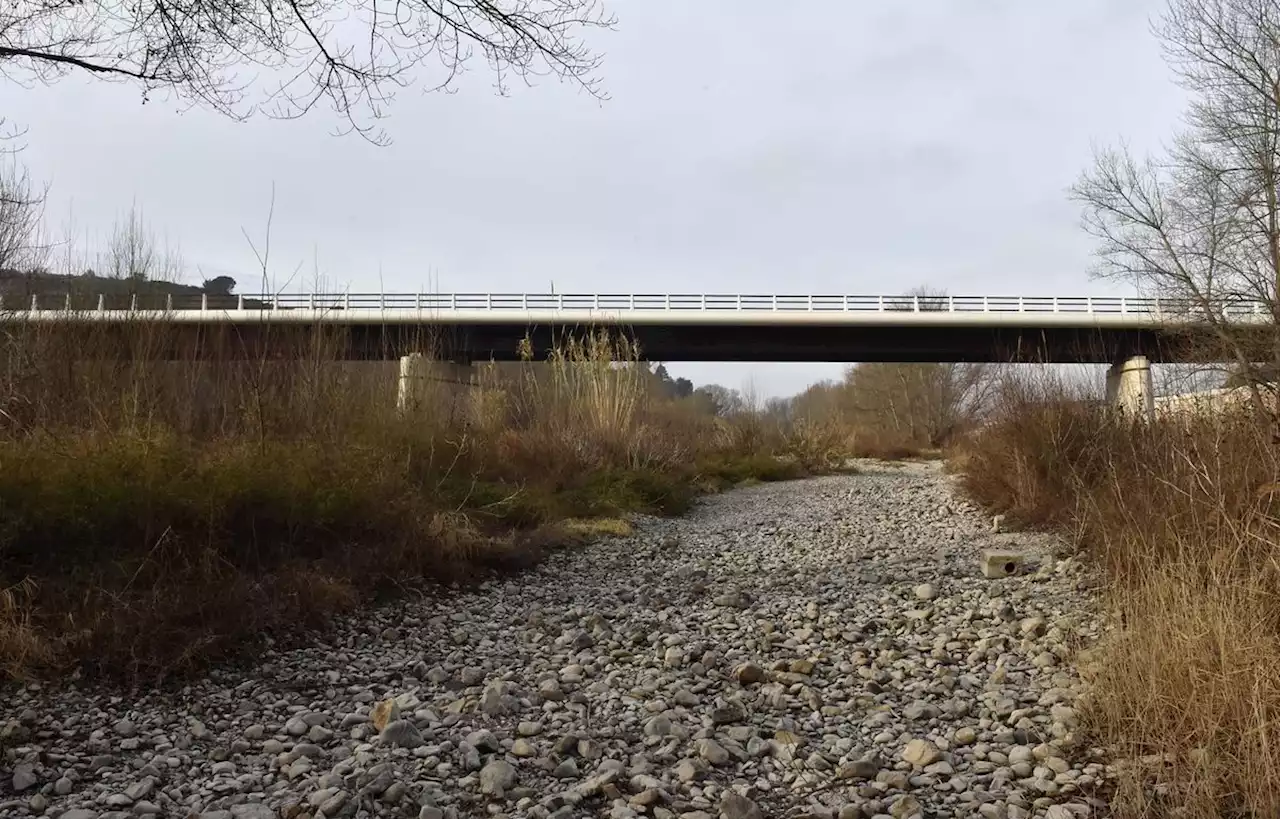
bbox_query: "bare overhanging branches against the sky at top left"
[0,0,613,142]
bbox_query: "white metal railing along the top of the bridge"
[0,293,1270,317]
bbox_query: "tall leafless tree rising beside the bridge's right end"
[1073,0,1280,402]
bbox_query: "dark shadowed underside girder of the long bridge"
[7,321,1212,363]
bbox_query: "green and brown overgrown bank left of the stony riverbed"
[0,326,840,681]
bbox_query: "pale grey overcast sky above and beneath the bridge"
[0,0,1183,394]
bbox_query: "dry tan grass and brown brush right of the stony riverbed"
[956,388,1280,819]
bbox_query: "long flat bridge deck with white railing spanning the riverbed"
[0,293,1271,363]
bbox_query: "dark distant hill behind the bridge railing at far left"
[0,269,265,310]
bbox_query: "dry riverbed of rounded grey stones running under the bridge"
[0,465,1105,819]
